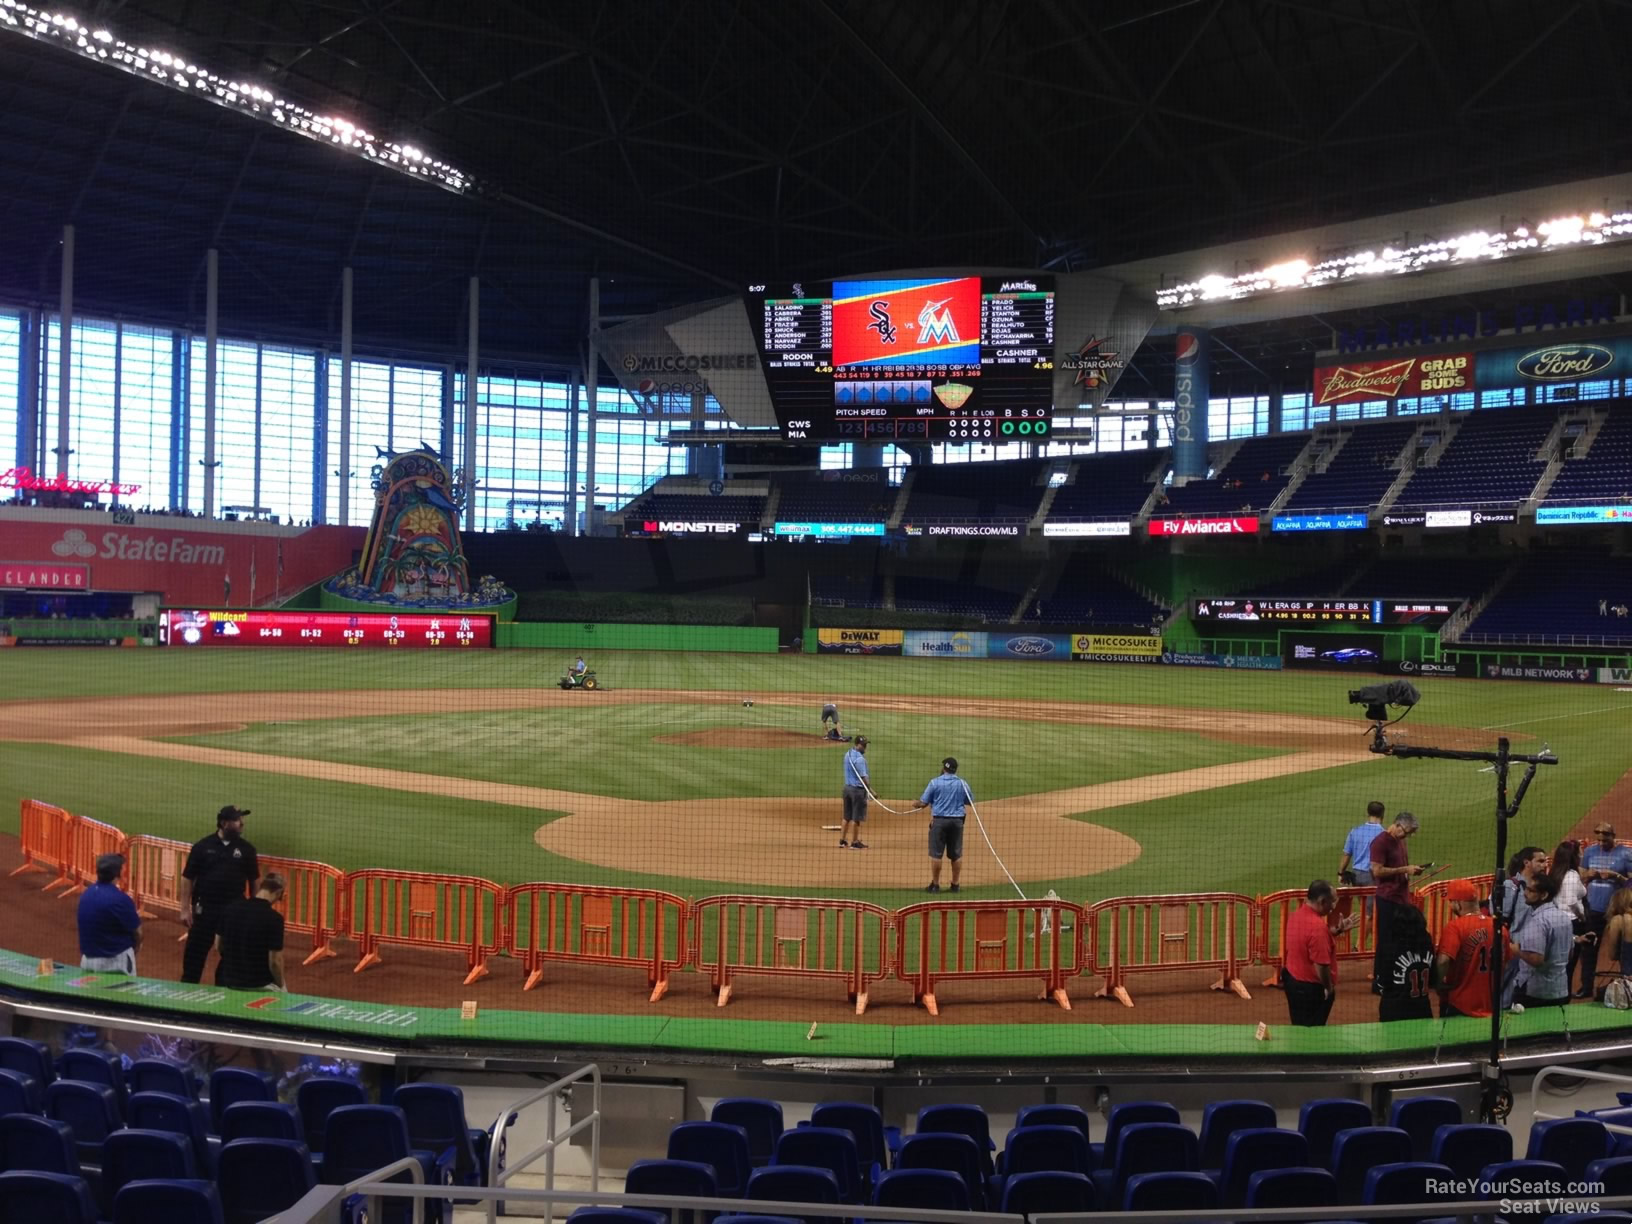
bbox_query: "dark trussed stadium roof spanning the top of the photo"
[0,0,1632,393]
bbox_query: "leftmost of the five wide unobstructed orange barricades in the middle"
[343,868,504,986]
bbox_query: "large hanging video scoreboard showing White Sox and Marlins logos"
[747,276,1054,442]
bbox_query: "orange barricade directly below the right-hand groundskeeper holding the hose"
[894,898,1087,1015]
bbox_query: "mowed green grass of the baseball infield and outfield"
[0,650,1632,904]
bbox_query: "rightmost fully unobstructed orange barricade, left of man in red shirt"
[1087,893,1260,1007]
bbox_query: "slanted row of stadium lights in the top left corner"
[0,0,485,196]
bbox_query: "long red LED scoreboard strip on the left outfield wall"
[158,607,493,650]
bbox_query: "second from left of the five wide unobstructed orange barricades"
[504,883,690,1002]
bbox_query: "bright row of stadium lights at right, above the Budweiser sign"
[1155,212,1632,310]
